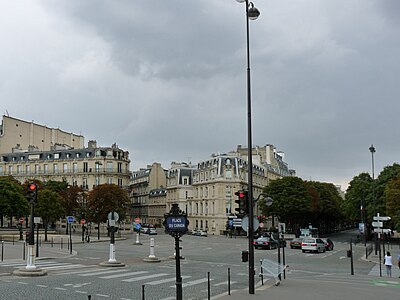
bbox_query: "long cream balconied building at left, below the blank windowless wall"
[0,141,131,190]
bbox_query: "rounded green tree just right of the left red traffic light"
[35,188,65,241]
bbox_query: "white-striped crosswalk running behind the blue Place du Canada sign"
[0,261,236,288]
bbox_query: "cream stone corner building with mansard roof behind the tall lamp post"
[187,145,295,235]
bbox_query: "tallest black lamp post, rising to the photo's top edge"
[236,0,260,294]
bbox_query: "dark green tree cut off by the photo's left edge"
[0,176,29,226]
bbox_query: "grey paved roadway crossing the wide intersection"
[0,234,398,300]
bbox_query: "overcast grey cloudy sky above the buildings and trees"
[0,0,400,190]
